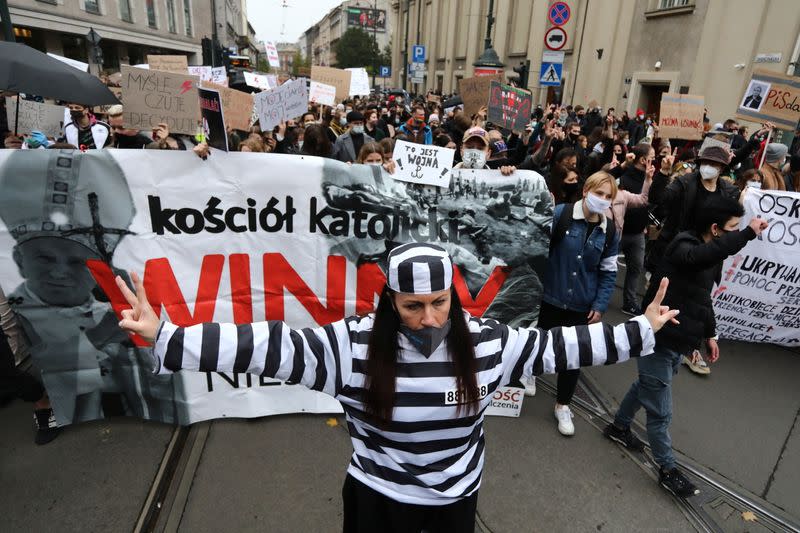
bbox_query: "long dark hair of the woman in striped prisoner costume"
[364,287,480,427]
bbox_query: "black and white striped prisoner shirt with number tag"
[154,313,655,505]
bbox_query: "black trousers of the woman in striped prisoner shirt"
[342,474,478,533]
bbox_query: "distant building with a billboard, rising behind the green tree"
[298,0,393,66]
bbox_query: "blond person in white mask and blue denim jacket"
[526,171,619,436]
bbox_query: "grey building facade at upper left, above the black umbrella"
[8,0,212,71]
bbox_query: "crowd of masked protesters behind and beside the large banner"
[0,76,800,502]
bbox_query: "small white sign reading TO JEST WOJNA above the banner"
[392,141,456,187]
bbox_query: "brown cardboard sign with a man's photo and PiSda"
[736,69,800,130]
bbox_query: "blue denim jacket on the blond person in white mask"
[544,202,619,313]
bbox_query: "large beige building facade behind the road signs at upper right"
[390,0,800,127]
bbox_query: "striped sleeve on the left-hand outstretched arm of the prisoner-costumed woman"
[153,320,351,396]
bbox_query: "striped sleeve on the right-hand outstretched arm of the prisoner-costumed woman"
[503,315,655,382]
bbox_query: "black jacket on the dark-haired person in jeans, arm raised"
[643,227,756,354]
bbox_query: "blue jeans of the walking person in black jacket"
[614,345,681,470]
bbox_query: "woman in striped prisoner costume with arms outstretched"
[117,243,675,533]
